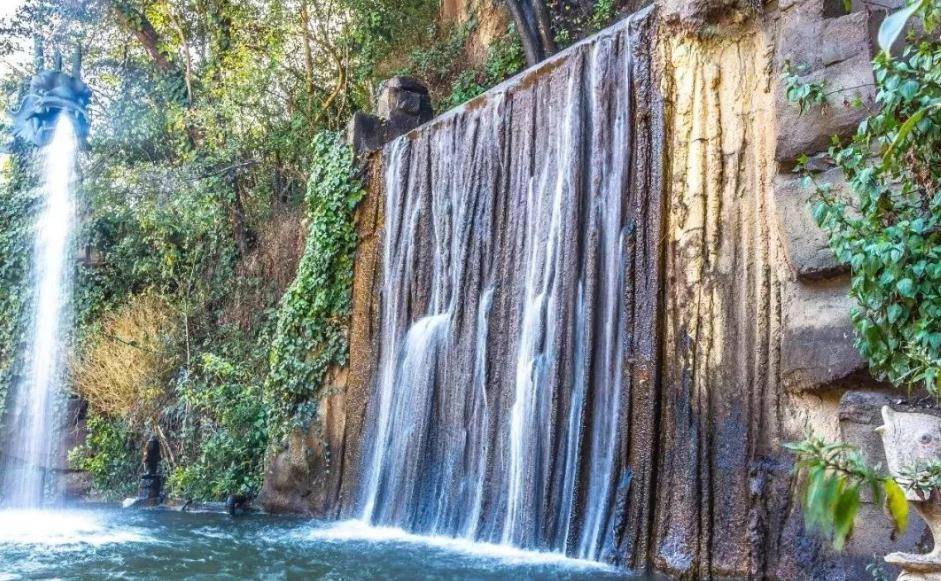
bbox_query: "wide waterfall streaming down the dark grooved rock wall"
[358,6,661,560]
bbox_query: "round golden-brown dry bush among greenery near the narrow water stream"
[72,294,180,421]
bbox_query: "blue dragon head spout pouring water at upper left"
[12,39,91,147]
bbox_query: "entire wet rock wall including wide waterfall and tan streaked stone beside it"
[265,0,900,579]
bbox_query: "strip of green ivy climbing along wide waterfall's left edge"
[265,132,364,440]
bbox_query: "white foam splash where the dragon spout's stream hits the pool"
[0,510,152,549]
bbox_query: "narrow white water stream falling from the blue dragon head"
[0,115,78,507]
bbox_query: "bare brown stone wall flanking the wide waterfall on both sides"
[265,0,923,579]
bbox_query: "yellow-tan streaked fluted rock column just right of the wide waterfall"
[654,22,788,577]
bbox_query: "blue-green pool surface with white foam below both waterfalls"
[0,508,648,580]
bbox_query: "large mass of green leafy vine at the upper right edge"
[808,1,941,395]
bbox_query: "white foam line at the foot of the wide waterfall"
[295,520,618,572]
